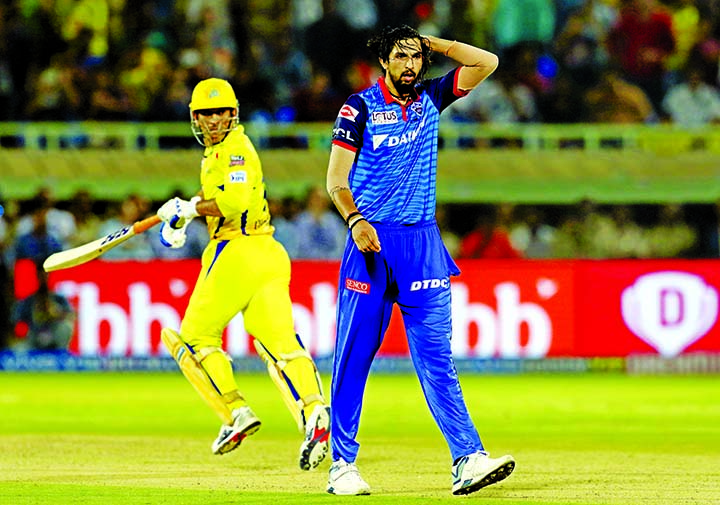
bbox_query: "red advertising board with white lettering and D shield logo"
[5,260,720,373]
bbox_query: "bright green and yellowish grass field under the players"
[0,372,720,505]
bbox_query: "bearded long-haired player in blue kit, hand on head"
[327,26,515,495]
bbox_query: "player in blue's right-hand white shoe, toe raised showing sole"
[452,452,515,494]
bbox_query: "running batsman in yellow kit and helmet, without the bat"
[158,78,330,470]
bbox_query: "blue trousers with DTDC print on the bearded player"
[330,222,483,462]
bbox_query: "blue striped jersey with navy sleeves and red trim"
[333,69,467,225]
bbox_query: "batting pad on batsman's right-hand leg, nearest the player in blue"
[253,339,325,432]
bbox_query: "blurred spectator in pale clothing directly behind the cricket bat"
[100,194,155,260]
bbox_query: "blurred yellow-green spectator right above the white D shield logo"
[646,203,698,258]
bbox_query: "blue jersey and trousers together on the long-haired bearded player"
[330,69,484,462]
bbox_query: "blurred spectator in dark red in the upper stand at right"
[607,0,676,110]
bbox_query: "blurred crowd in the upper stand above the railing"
[0,0,720,127]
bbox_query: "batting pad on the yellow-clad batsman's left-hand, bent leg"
[160,328,242,424]
